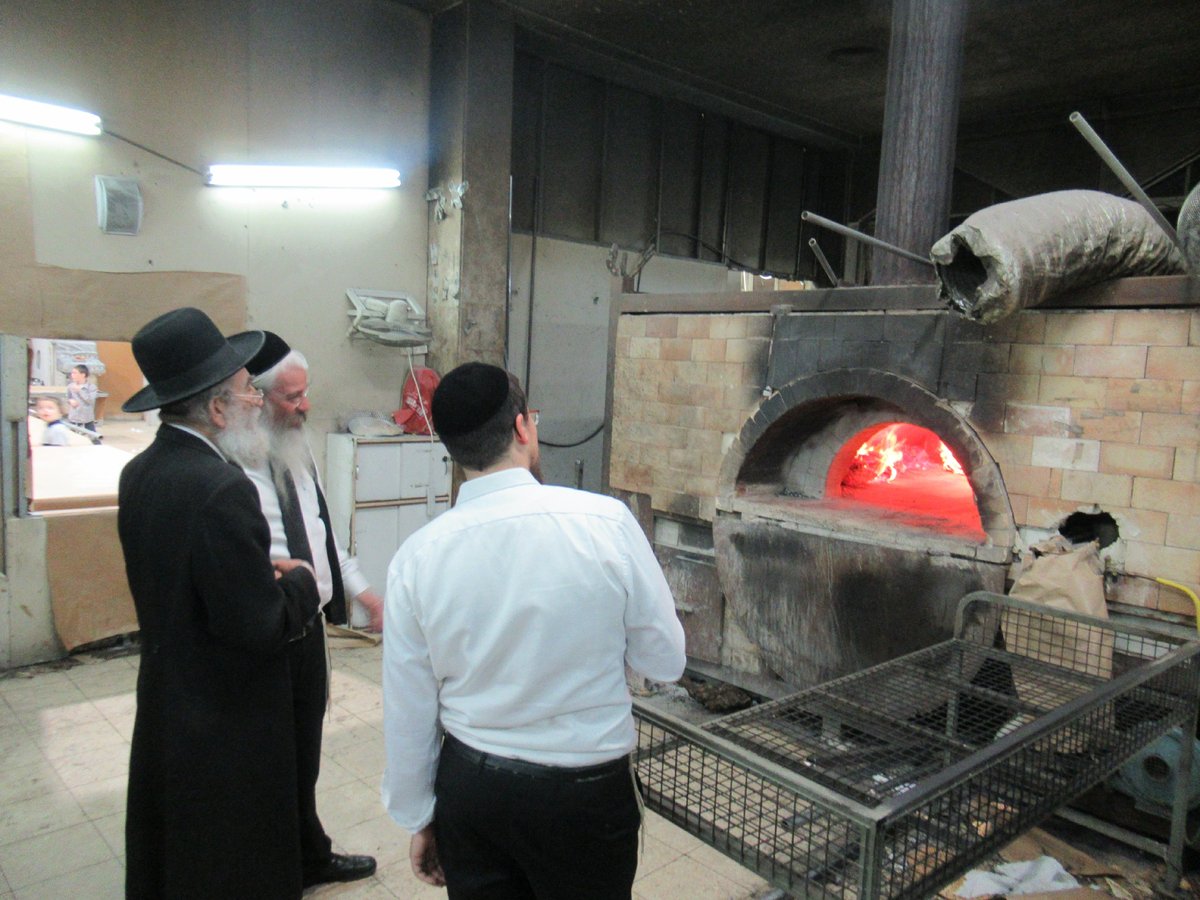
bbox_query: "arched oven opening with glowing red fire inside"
[716,368,1016,562]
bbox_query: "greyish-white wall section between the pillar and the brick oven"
[508,234,731,491]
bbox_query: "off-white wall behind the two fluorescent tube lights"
[0,0,430,475]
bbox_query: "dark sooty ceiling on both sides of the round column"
[500,0,1200,145]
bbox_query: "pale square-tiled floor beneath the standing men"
[0,644,768,900]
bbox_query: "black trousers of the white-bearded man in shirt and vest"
[288,617,332,871]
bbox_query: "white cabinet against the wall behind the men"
[325,434,450,628]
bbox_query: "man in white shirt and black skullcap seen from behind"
[383,362,685,900]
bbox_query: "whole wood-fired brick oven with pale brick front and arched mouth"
[608,277,1200,686]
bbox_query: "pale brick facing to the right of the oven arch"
[968,310,1200,614]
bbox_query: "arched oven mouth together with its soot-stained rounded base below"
[714,355,1014,686]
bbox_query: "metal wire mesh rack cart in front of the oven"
[635,592,1200,898]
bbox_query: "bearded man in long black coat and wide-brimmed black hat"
[118,308,318,900]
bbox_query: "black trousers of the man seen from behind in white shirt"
[434,734,641,900]
